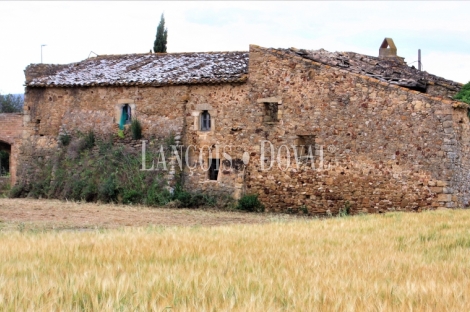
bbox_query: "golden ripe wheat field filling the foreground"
[0,210,470,311]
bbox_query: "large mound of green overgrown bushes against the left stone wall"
[10,136,224,208]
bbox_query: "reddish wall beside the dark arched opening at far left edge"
[0,113,23,185]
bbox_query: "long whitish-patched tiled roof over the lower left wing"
[25,52,248,87]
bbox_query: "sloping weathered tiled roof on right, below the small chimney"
[286,48,462,91]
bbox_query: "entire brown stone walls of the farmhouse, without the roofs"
[21,46,470,214]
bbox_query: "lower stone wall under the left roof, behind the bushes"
[21,83,248,195]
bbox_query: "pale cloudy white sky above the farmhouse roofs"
[0,1,470,94]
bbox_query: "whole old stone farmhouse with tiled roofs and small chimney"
[16,38,470,214]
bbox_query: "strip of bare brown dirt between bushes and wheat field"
[0,198,289,230]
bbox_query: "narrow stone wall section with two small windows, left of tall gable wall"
[184,84,252,198]
